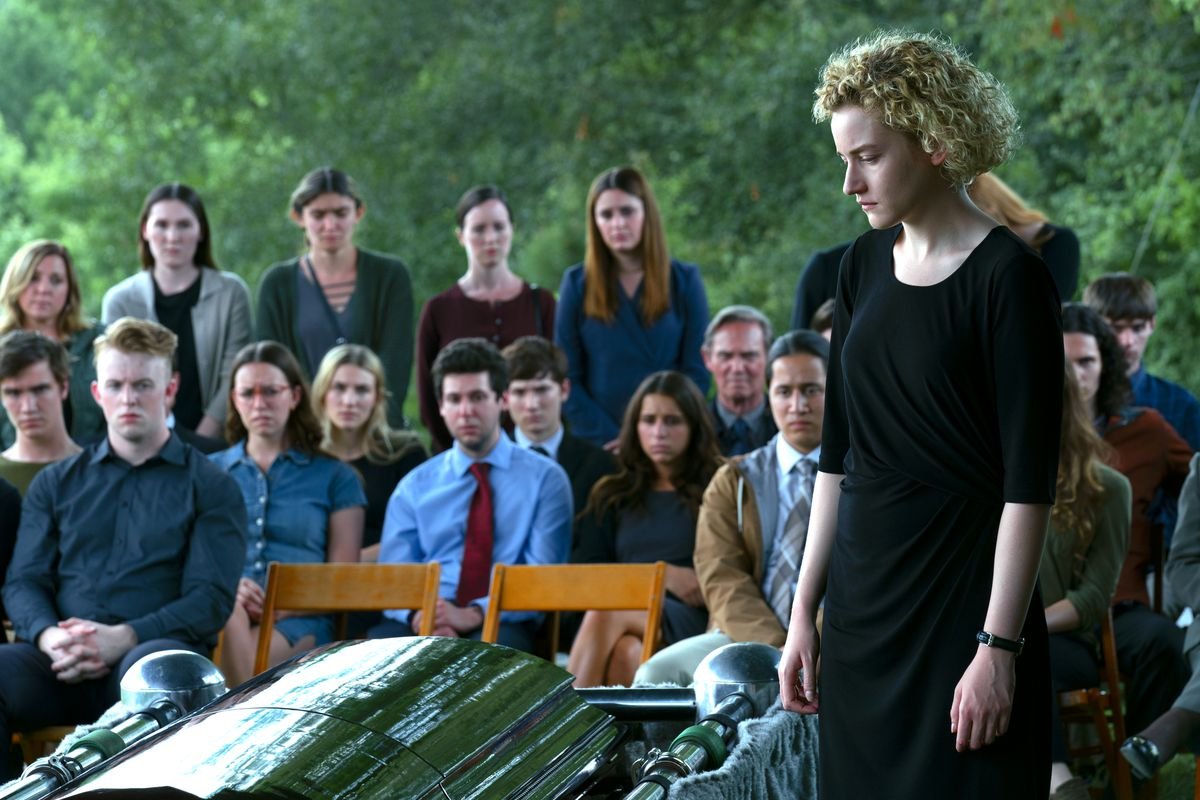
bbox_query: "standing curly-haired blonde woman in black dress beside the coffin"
[780,32,1062,800]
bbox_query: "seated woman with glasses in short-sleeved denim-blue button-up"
[211,342,366,686]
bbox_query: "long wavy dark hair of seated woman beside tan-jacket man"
[583,371,724,516]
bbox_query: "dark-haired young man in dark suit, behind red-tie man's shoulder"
[503,336,617,542]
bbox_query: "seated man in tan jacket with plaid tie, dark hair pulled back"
[637,331,829,685]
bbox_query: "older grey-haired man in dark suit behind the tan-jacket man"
[701,306,775,456]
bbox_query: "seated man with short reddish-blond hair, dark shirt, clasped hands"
[0,318,246,778]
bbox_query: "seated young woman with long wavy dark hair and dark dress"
[568,372,721,686]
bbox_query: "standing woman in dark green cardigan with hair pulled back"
[258,167,413,427]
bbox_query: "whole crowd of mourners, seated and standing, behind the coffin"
[0,168,1200,796]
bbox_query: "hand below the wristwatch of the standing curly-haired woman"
[950,644,1016,753]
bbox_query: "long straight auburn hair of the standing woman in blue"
[583,167,671,325]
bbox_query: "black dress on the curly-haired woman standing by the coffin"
[820,227,1063,800]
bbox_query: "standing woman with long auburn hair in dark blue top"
[554,167,709,450]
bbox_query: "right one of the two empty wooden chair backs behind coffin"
[481,561,667,663]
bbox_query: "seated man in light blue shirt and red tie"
[368,338,572,651]
